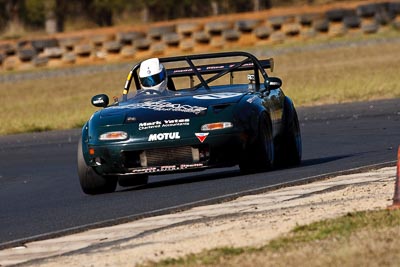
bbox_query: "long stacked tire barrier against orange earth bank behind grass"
[0,1,400,71]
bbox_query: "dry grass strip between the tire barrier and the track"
[0,29,400,135]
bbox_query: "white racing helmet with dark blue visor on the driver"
[139,58,167,91]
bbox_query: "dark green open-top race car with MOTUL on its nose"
[78,52,301,194]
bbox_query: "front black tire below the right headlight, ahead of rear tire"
[239,113,275,173]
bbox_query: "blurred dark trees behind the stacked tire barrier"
[0,0,324,37]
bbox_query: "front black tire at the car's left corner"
[77,137,117,195]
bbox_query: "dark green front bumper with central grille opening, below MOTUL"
[87,133,246,175]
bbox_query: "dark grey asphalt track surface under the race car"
[0,99,400,248]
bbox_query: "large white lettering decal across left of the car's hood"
[110,100,207,115]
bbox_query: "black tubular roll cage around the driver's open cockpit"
[123,52,274,101]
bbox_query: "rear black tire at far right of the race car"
[275,98,302,167]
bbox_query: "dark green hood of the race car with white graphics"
[99,92,246,125]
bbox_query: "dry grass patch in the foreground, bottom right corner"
[143,210,400,267]
